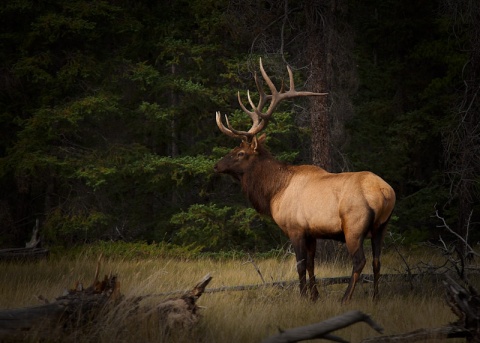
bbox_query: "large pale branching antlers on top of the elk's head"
[216,58,328,142]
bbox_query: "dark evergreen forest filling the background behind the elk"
[0,0,480,252]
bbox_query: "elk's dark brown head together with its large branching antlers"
[214,58,327,179]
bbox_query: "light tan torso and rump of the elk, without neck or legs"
[271,165,395,238]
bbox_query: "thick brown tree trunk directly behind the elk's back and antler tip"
[305,0,356,262]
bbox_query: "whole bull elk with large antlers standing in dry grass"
[214,59,395,302]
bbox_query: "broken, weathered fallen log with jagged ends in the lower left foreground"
[0,257,212,341]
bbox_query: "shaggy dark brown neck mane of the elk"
[240,145,292,216]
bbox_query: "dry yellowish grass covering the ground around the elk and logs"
[0,250,478,343]
